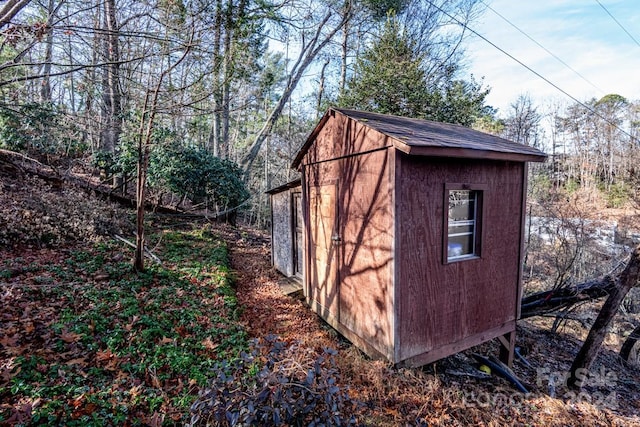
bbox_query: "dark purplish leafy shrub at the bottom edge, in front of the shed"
[190,336,360,426]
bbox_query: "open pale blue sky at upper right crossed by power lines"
[466,0,640,116]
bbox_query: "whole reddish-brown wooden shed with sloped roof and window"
[288,109,545,366]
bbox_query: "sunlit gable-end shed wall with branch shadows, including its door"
[303,115,393,356]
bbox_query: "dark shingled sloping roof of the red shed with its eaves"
[293,108,547,167]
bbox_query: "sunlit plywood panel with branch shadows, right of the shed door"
[339,150,393,354]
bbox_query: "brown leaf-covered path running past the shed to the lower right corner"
[226,229,640,426]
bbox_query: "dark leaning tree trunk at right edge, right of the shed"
[567,246,640,389]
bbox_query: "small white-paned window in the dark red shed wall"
[445,189,482,262]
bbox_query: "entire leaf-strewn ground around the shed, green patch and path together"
[0,166,640,426]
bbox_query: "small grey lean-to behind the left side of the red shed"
[267,179,304,281]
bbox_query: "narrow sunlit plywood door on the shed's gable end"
[309,184,340,320]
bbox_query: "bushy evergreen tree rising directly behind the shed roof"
[338,16,492,126]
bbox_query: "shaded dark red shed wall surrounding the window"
[395,155,524,360]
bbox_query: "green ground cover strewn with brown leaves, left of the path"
[0,230,246,426]
